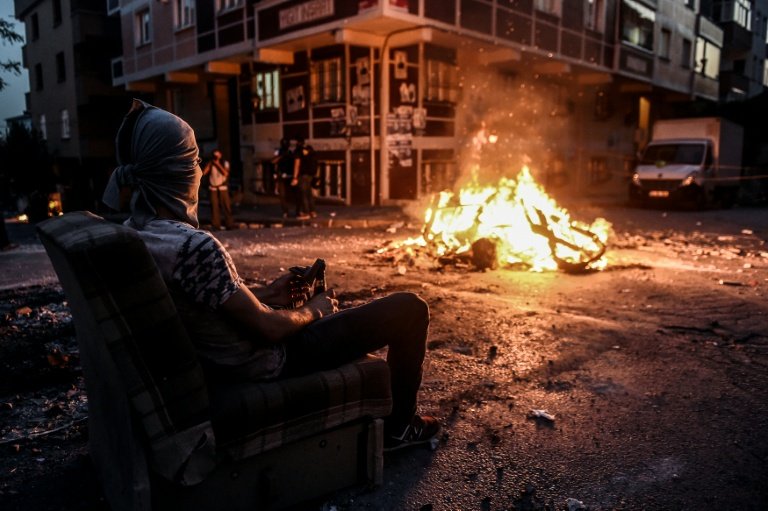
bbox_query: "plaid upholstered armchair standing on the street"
[38,212,391,510]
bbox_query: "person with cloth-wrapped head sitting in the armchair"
[103,100,440,450]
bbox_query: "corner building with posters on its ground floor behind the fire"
[107,0,723,204]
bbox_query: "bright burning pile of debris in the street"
[401,166,611,271]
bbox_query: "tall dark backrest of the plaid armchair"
[37,212,215,484]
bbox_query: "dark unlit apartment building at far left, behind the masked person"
[14,0,130,209]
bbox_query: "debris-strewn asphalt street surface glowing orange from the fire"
[0,206,768,511]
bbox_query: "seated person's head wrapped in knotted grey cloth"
[103,99,201,228]
